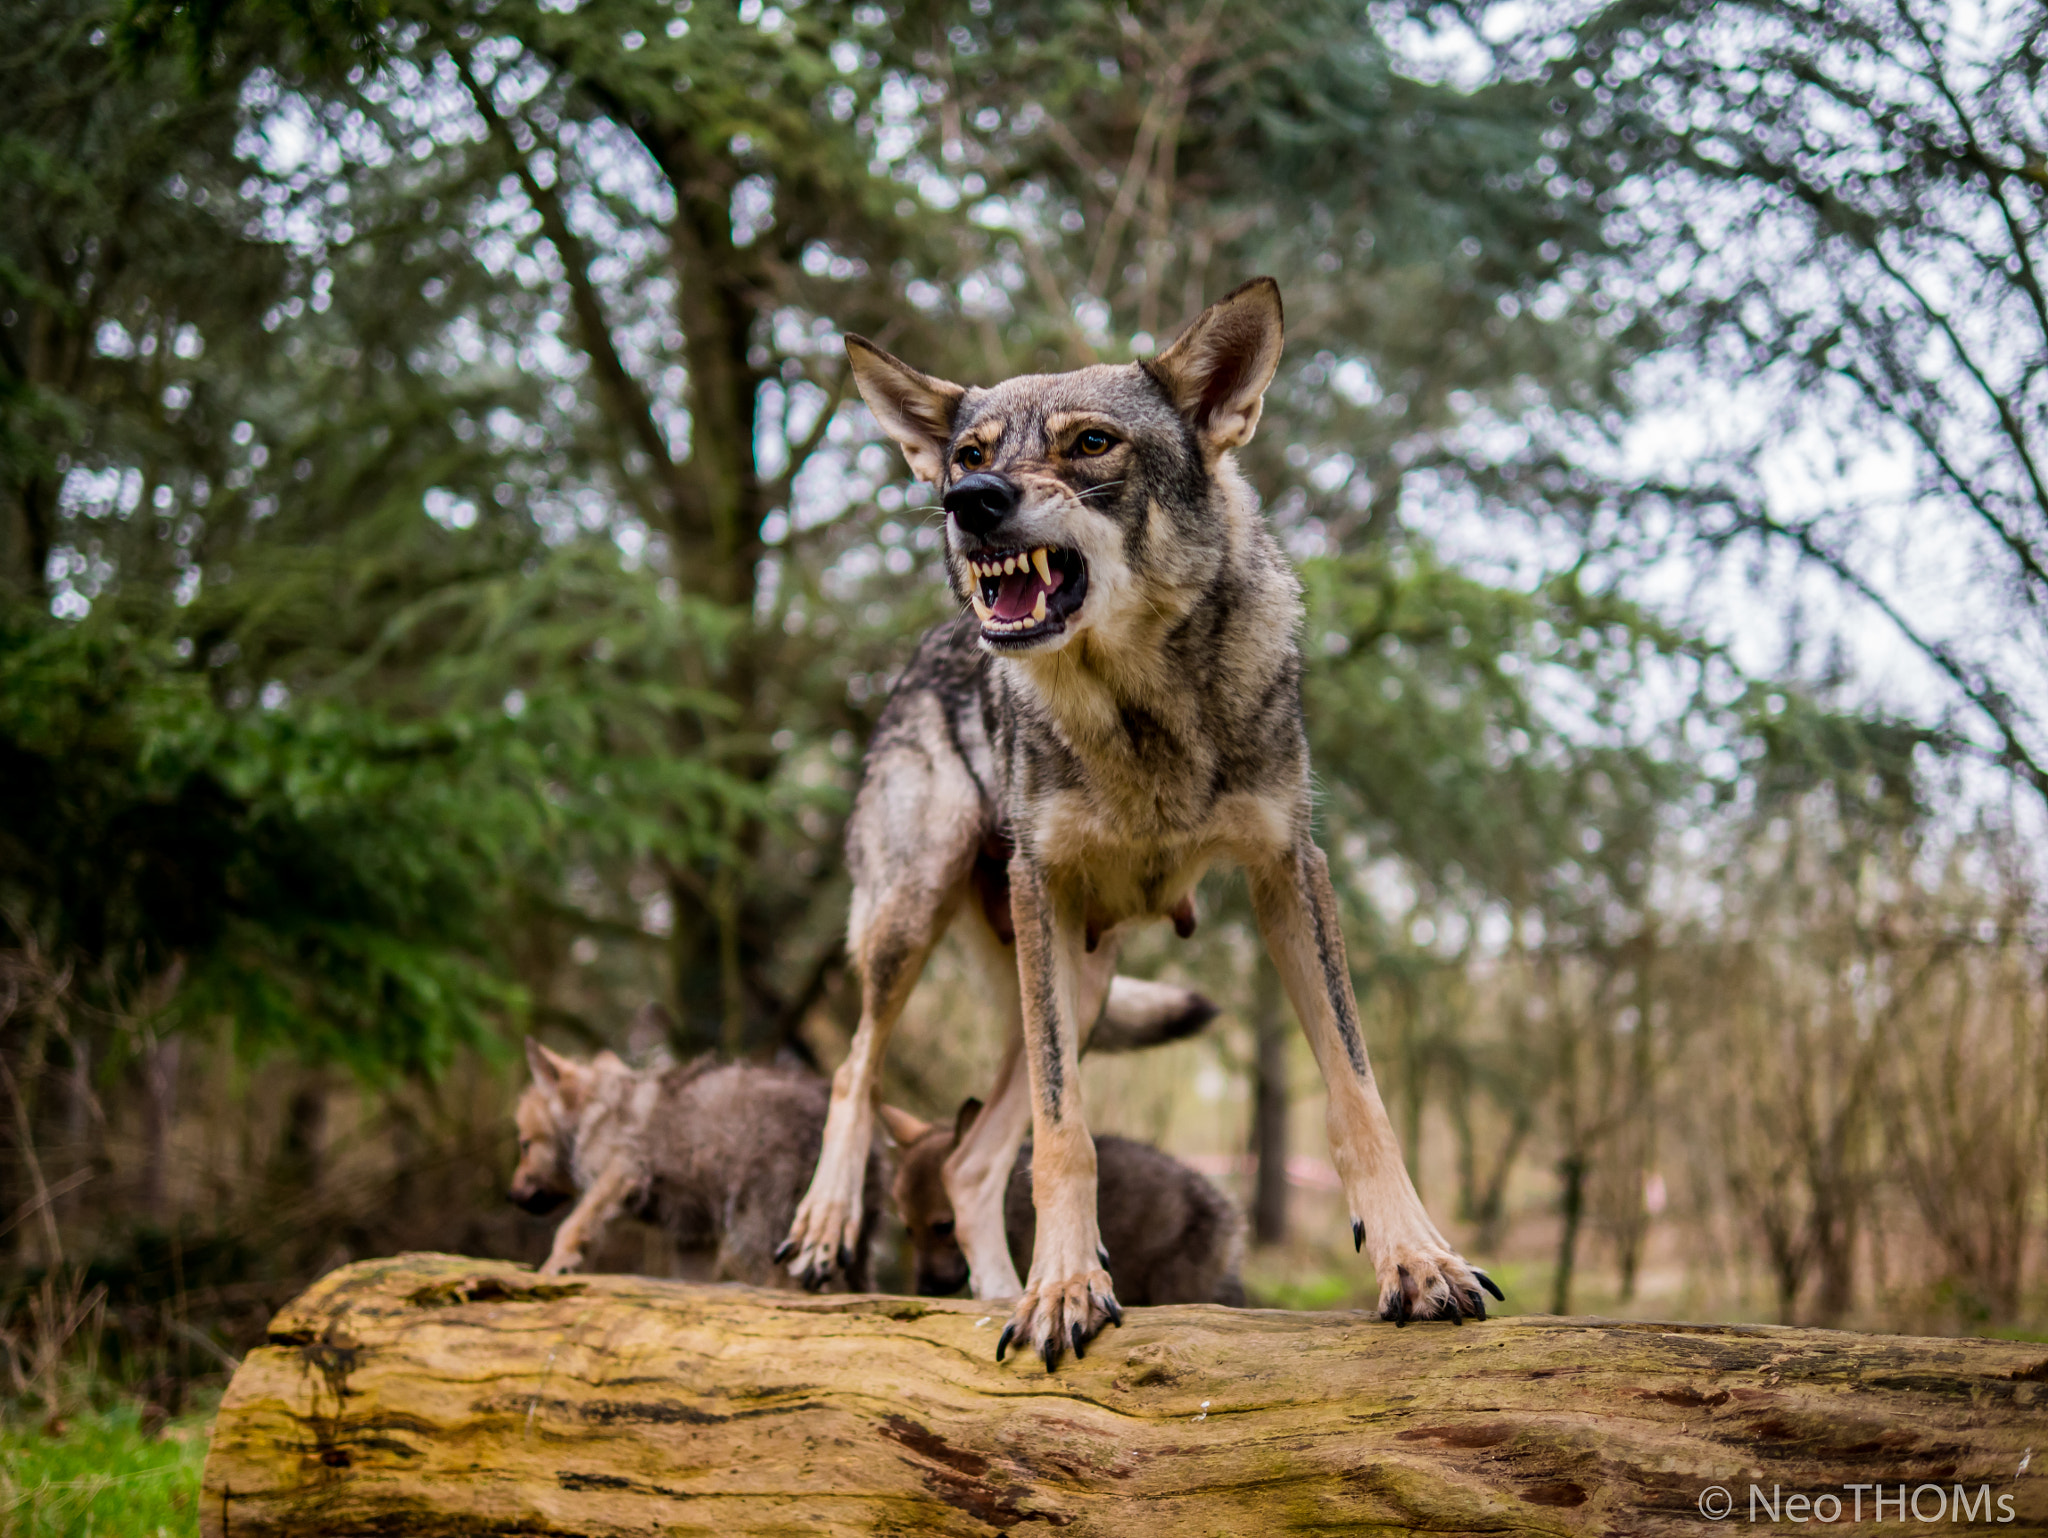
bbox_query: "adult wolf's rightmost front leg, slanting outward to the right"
[1251,838,1501,1325]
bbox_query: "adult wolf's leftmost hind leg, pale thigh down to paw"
[774,696,983,1290]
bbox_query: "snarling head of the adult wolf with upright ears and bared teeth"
[846,279,1282,655]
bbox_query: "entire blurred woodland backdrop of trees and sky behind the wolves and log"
[0,0,2048,1441]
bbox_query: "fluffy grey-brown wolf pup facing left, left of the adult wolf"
[510,1038,883,1292]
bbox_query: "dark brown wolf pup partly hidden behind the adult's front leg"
[879,1100,1245,1309]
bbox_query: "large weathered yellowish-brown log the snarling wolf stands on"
[201,1255,2048,1538]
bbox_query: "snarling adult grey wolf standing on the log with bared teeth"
[782,279,1499,1370]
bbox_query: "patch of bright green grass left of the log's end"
[0,1405,213,1538]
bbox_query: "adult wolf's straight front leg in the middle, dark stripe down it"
[995,854,1124,1372]
